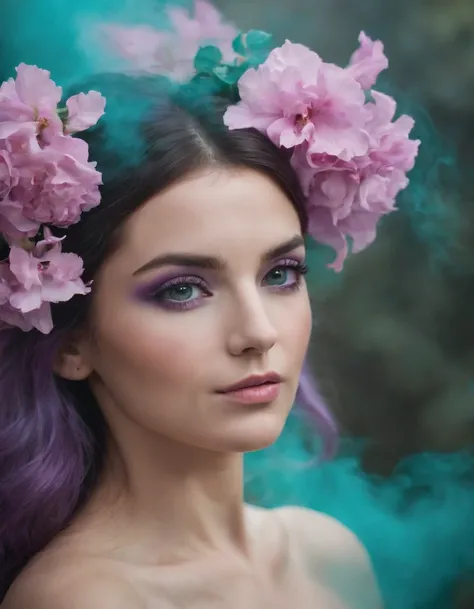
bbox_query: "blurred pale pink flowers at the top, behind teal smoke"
[103,0,237,82]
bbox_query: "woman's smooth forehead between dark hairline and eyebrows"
[111,169,301,266]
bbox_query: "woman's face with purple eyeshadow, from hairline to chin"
[79,169,311,452]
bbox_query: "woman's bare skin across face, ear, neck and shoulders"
[2,170,380,609]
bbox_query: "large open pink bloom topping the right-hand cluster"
[224,41,369,160]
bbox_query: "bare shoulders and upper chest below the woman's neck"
[2,506,382,609]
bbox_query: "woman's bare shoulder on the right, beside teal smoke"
[277,507,382,609]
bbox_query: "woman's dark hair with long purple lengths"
[0,75,331,599]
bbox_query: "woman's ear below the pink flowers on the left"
[53,332,93,381]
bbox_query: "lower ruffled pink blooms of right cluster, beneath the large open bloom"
[293,92,420,271]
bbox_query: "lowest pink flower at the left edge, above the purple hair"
[0,236,90,334]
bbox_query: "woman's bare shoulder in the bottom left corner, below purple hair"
[0,557,144,609]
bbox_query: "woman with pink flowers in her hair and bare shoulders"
[0,21,417,609]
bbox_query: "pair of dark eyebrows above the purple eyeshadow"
[133,235,304,276]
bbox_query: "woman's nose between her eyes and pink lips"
[228,290,278,356]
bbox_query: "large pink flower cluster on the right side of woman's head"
[224,33,419,270]
